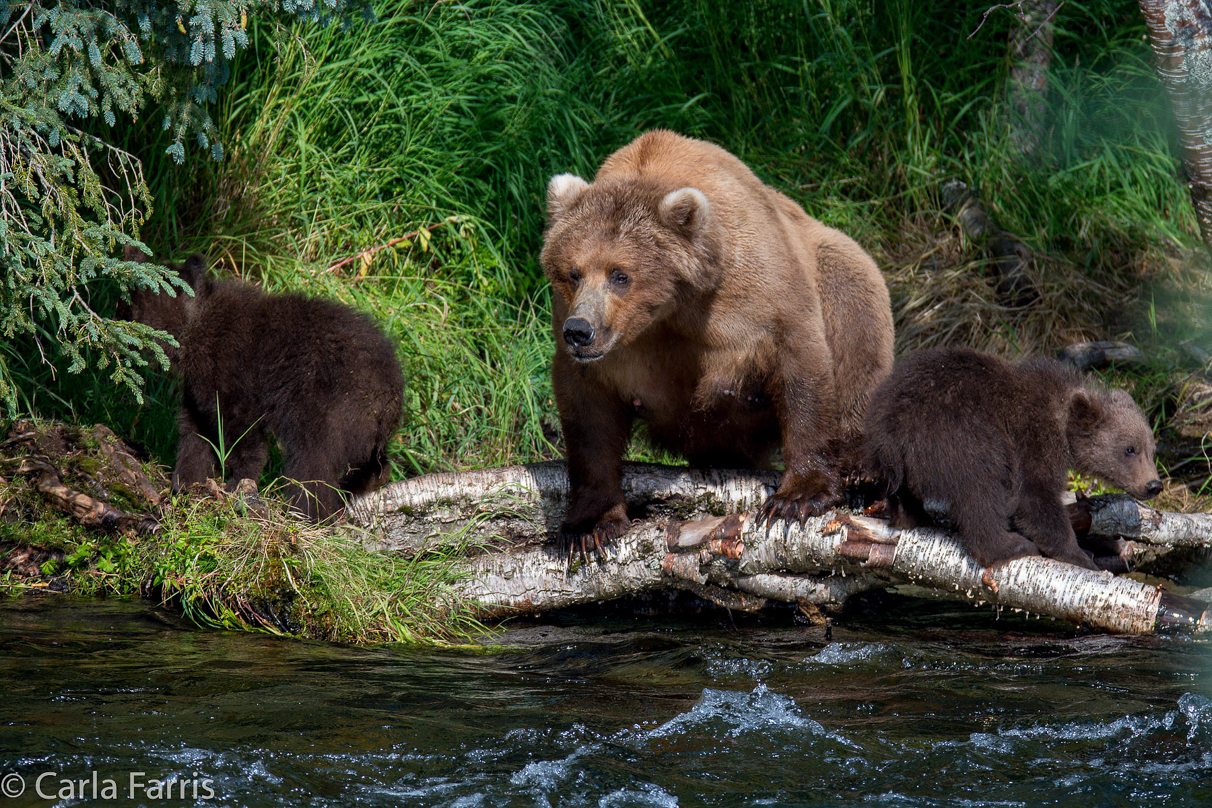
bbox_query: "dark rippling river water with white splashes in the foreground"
[0,596,1212,808]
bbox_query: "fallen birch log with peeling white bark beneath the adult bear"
[349,463,1212,634]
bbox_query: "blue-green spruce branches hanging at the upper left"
[0,0,361,413]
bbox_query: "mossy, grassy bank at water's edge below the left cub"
[0,420,484,642]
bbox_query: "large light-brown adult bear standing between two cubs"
[542,130,893,550]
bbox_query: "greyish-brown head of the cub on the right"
[1065,388,1162,499]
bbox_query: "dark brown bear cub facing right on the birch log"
[865,348,1162,569]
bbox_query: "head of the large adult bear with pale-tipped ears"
[542,174,716,362]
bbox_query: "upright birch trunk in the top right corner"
[1140,0,1212,250]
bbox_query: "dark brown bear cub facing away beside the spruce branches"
[120,248,404,520]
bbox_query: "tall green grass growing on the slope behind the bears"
[9,0,1193,475]
